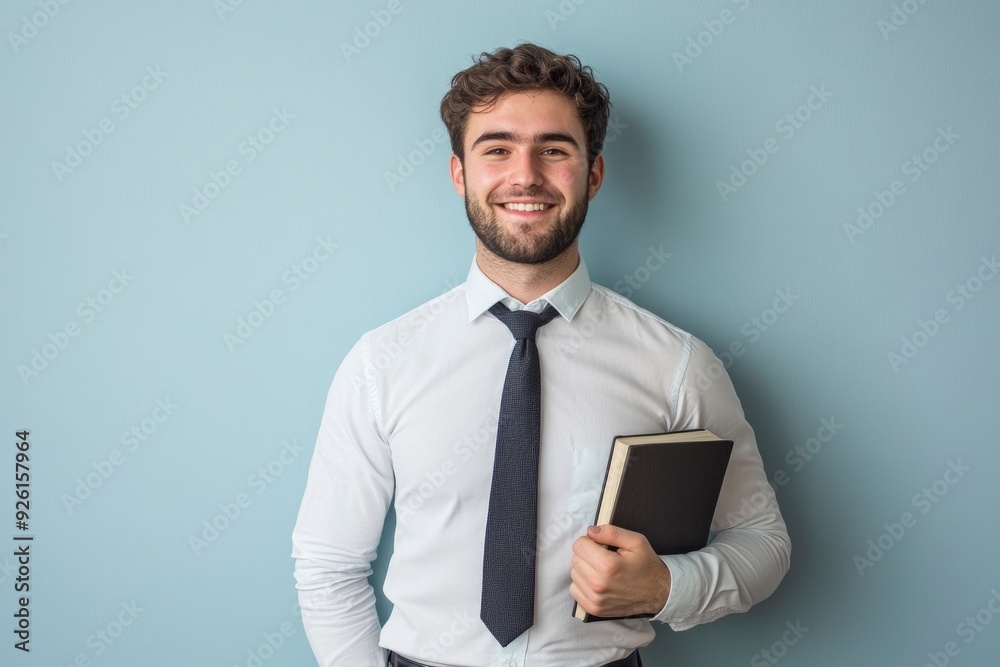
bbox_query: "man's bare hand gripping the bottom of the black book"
[569,525,670,616]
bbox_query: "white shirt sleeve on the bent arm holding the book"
[654,338,791,630]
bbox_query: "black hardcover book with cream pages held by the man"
[573,429,733,623]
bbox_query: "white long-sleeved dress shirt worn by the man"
[292,260,790,667]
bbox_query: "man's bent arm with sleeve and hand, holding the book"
[571,339,791,630]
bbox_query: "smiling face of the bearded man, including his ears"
[451,90,604,264]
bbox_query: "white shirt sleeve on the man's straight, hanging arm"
[292,335,394,667]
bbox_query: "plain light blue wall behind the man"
[0,0,1000,667]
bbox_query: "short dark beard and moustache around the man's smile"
[465,188,590,264]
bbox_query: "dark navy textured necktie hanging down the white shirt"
[479,303,556,646]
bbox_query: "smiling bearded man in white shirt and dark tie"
[293,44,790,667]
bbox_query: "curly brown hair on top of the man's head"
[441,43,611,166]
